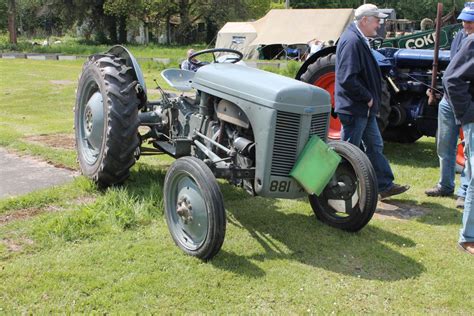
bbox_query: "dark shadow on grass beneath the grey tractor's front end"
[215,185,426,281]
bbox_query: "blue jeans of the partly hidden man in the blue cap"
[436,98,468,197]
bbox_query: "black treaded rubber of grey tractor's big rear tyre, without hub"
[75,54,140,188]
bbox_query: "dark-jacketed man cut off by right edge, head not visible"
[443,30,474,255]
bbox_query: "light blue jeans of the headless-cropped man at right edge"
[459,123,474,243]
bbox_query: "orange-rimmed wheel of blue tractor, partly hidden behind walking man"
[300,53,391,140]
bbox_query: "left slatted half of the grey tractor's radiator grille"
[271,111,301,177]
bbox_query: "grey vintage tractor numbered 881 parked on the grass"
[74,46,377,260]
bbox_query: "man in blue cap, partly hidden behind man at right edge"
[425,2,474,208]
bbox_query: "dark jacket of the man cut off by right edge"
[443,34,474,124]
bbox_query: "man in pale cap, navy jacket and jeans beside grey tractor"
[335,4,409,198]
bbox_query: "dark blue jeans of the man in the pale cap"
[337,113,394,192]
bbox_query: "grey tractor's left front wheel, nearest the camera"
[163,157,226,260]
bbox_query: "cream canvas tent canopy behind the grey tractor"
[216,9,354,58]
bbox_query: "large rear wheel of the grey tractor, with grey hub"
[74,55,140,187]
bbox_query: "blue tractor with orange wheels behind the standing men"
[296,46,464,165]
